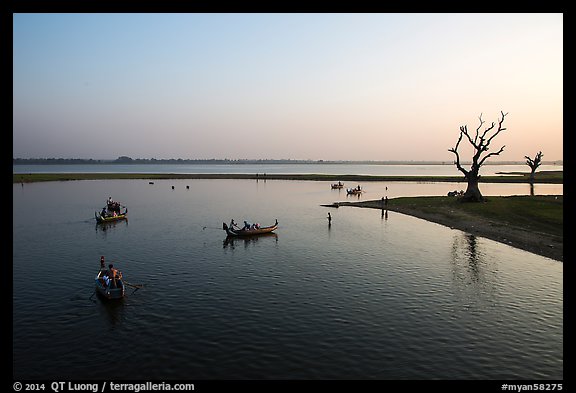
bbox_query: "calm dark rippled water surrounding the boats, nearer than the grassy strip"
[13,180,564,381]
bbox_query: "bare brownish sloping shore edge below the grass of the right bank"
[338,199,564,261]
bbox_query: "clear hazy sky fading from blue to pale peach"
[13,13,563,162]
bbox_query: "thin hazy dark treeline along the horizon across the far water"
[12,156,563,165]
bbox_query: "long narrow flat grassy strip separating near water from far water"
[12,171,564,184]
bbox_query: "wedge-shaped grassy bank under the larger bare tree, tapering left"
[339,195,564,261]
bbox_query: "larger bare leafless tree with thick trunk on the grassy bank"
[448,112,508,202]
